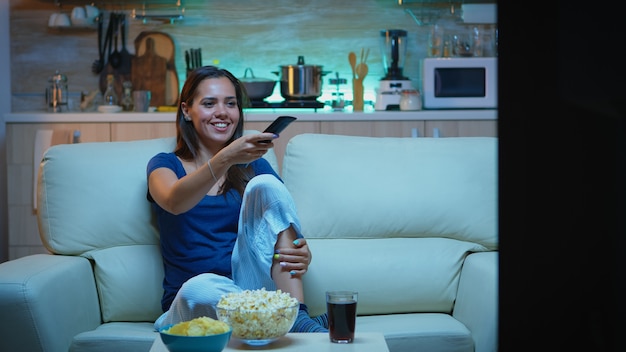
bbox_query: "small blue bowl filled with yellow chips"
[159,317,232,352]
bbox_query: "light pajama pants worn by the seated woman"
[154,175,302,330]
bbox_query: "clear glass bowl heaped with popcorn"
[217,288,300,346]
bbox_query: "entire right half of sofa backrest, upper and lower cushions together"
[282,134,498,315]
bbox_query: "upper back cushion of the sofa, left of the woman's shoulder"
[37,138,174,255]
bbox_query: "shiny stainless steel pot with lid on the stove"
[273,56,330,100]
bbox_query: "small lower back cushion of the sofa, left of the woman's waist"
[84,245,163,322]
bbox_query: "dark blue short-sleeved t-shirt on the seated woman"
[147,153,280,311]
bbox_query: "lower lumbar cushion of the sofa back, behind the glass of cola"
[302,238,485,315]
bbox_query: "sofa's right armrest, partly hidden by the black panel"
[452,251,498,352]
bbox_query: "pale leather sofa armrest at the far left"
[0,254,100,352]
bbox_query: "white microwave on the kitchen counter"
[422,57,498,109]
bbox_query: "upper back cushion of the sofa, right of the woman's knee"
[282,134,498,249]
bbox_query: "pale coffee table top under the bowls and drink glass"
[150,332,389,352]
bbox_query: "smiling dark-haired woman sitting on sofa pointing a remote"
[147,66,328,332]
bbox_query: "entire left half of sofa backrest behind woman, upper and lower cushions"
[37,131,278,322]
